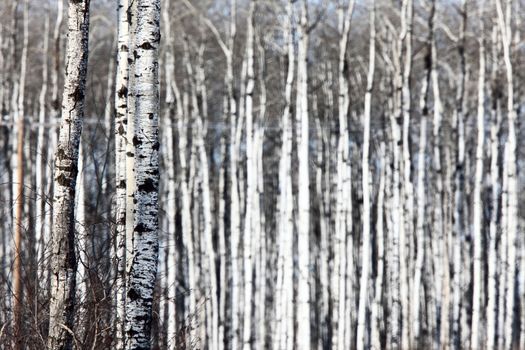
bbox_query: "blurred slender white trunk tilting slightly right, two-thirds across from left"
[357,1,376,350]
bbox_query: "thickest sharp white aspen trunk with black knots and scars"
[126,0,160,349]
